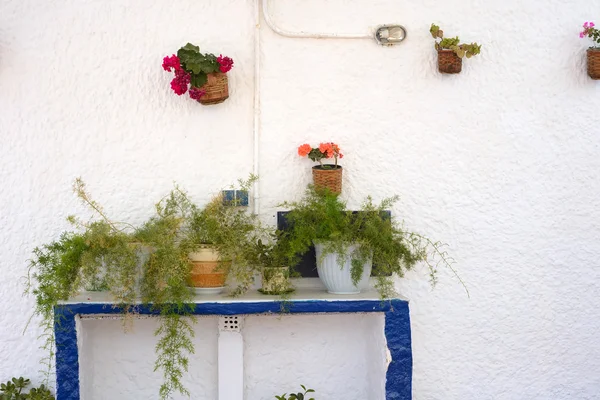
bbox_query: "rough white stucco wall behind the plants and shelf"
[0,0,600,400]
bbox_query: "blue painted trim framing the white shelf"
[54,299,412,400]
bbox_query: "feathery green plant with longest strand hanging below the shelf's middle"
[135,187,196,399]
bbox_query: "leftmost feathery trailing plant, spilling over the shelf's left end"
[26,179,137,379]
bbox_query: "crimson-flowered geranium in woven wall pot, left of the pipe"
[163,43,233,105]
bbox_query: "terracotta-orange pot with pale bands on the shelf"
[189,247,231,288]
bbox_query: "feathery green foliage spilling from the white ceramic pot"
[282,186,468,298]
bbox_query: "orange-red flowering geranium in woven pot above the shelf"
[298,142,344,194]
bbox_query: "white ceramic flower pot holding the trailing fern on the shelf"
[315,244,373,294]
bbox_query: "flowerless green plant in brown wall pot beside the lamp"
[429,24,481,74]
